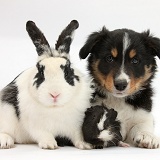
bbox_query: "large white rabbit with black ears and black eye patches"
[0,20,93,149]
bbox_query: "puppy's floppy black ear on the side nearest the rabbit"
[79,27,109,59]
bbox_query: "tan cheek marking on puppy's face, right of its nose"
[129,65,152,94]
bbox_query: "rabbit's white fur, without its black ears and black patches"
[0,20,92,149]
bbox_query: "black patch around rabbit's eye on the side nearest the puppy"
[60,60,80,86]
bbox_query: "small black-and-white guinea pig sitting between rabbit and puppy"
[82,104,129,149]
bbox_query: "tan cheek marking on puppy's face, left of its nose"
[92,60,114,92]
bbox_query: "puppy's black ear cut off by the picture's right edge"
[142,30,160,59]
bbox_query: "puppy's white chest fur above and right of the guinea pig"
[94,95,151,140]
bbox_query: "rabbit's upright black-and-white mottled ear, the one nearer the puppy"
[55,20,79,58]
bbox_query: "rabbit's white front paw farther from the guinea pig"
[38,140,58,149]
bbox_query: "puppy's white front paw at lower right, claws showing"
[133,132,160,149]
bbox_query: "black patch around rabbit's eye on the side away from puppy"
[33,63,45,88]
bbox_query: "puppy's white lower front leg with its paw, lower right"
[127,116,160,149]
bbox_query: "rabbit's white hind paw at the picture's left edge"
[0,133,14,149]
